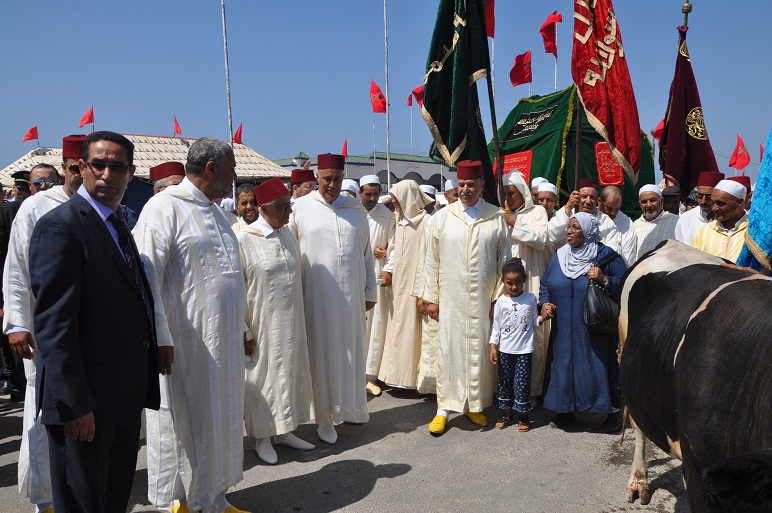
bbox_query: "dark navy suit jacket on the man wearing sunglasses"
[29,194,160,424]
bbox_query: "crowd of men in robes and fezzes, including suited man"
[0,131,750,513]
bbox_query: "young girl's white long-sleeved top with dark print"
[490,291,539,354]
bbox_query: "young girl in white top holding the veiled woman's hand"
[490,258,553,431]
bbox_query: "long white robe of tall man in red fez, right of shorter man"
[289,191,377,425]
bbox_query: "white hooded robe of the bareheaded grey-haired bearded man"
[134,178,247,511]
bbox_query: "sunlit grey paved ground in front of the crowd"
[0,391,689,513]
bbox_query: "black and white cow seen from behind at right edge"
[619,240,772,512]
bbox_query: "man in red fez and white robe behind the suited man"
[2,135,86,511]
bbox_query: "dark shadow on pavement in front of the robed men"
[228,460,411,513]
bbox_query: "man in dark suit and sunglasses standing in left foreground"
[29,132,160,513]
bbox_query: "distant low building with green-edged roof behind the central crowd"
[274,151,456,192]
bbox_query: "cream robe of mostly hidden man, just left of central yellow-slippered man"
[411,216,439,394]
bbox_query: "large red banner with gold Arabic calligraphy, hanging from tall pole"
[571,0,641,184]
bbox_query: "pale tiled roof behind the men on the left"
[0,134,290,187]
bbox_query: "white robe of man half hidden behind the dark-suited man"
[3,186,70,504]
